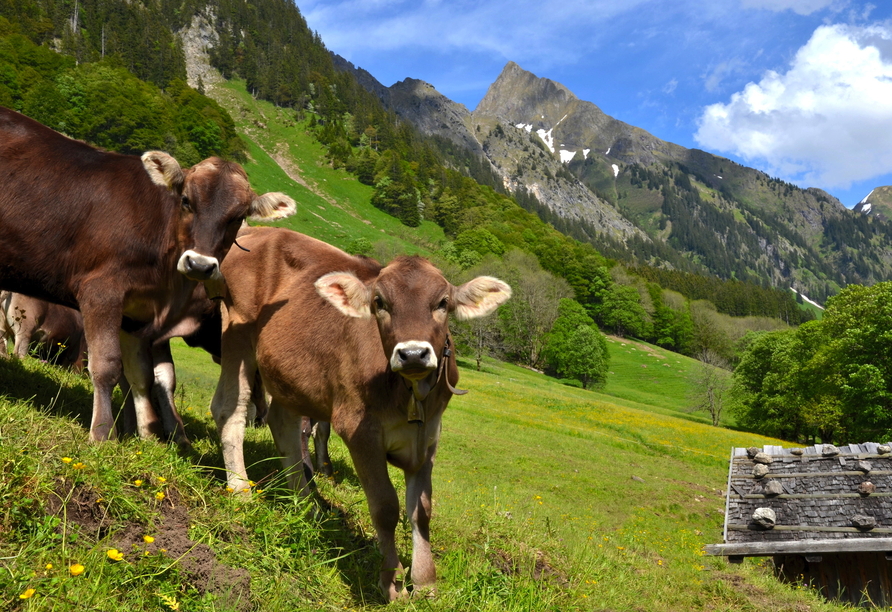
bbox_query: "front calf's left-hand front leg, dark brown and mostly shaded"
[347,438,408,601]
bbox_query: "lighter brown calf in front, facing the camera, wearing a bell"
[211,228,511,600]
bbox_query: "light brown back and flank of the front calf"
[223,228,387,421]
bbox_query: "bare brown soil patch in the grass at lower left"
[48,482,251,610]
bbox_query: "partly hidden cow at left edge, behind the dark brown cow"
[0,291,87,372]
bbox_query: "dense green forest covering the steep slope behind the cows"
[0,0,810,384]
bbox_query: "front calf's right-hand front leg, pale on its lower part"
[406,457,437,595]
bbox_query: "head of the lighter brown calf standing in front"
[316,257,511,381]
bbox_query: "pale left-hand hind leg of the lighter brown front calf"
[211,338,257,493]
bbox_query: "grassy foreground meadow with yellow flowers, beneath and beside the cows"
[0,344,852,611]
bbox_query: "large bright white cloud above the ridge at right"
[694,24,892,188]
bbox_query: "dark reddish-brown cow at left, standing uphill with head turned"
[0,108,294,440]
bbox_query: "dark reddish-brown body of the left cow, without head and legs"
[0,108,178,307]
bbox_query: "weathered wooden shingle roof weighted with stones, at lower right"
[707,442,892,556]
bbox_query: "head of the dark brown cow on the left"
[142,151,295,281]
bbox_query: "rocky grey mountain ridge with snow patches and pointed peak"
[341,56,892,299]
